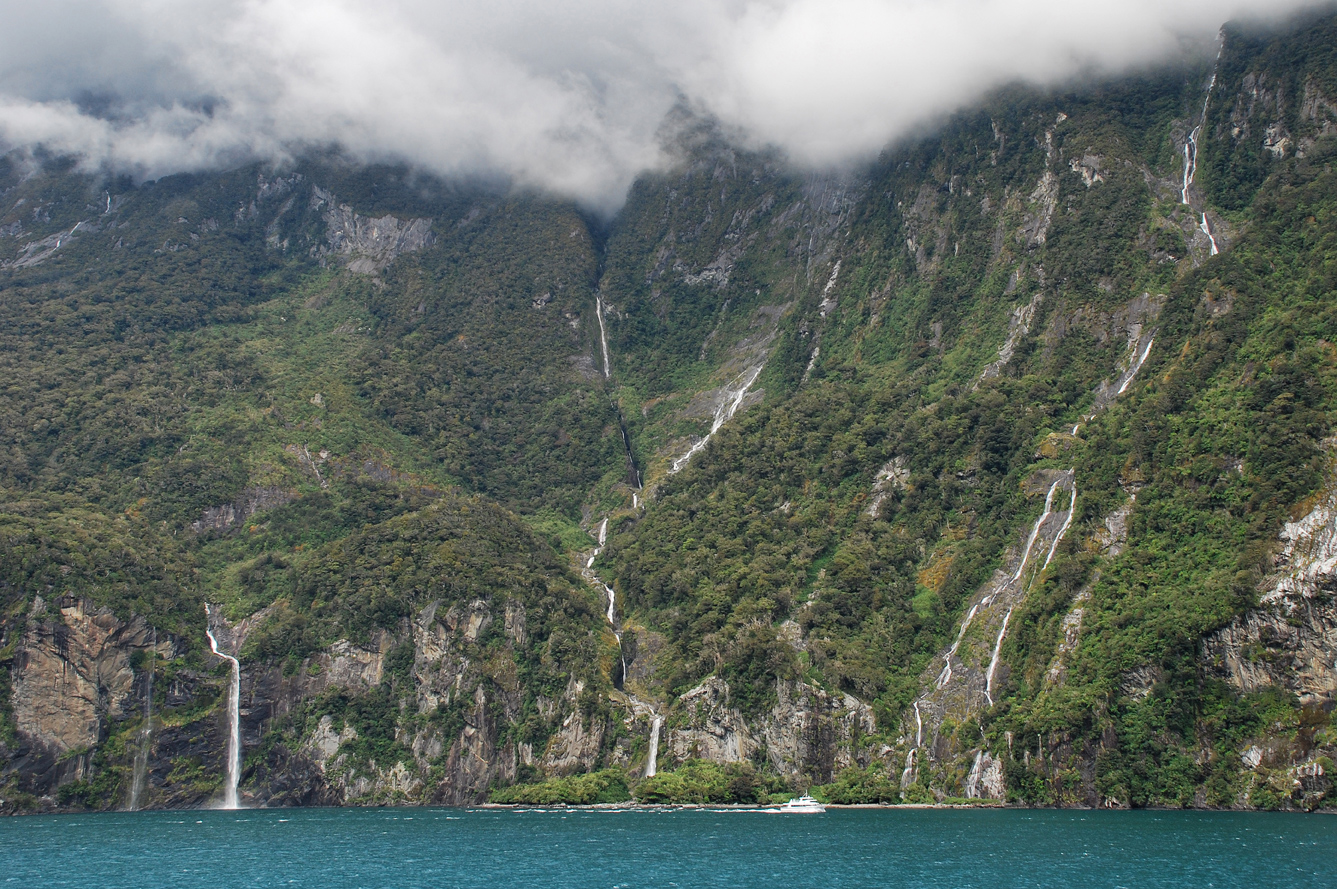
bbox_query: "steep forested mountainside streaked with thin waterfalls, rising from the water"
[0,8,1337,811]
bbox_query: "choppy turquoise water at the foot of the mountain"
[0,809,1337,889]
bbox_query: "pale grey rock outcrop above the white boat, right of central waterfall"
[667,676,876,781]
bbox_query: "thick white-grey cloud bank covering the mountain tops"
[0,0,1308,210]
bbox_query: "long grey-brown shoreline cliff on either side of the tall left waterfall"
[0,585,607,811]
